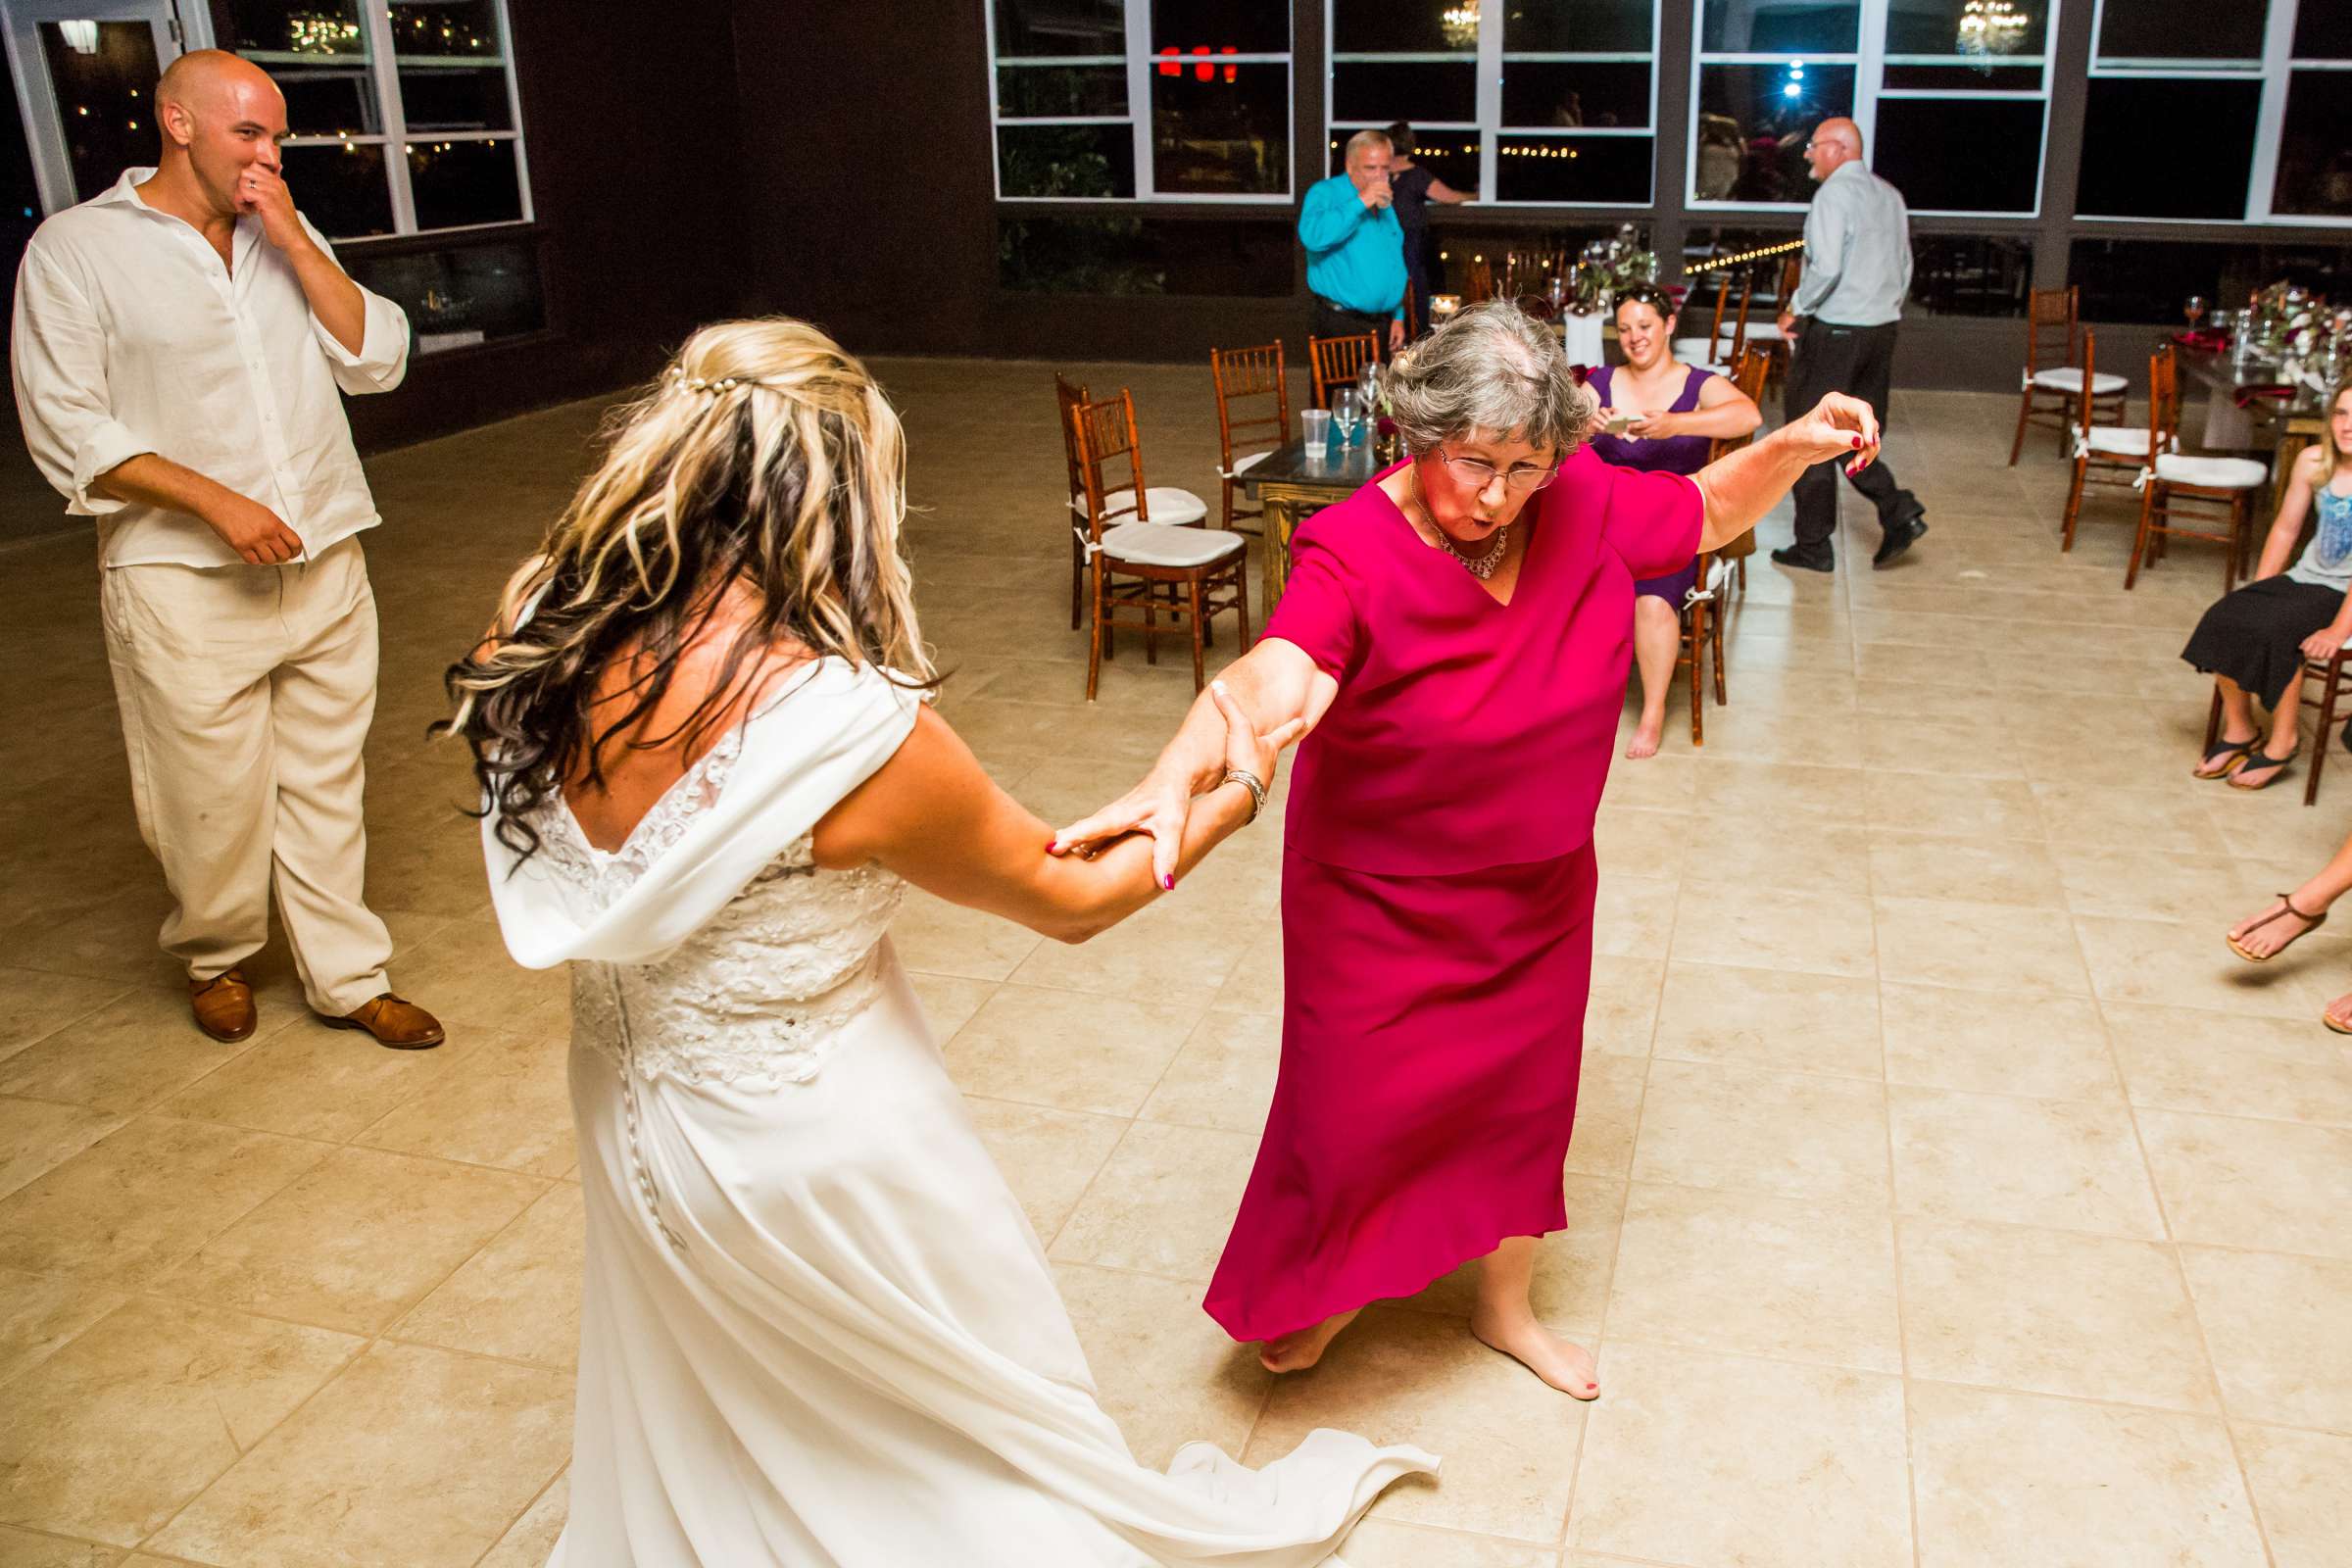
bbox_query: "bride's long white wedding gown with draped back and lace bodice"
[484,661,1437,1568]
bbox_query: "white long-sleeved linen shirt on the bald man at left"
[10,170,410,566]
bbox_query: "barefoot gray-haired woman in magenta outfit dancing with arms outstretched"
[1056,303,1880,1398]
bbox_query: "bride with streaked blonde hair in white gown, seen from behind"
[449,319,1437,1568]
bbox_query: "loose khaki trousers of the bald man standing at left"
[101,538,393,1015]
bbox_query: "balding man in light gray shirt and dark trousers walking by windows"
[1771,120,1927,571]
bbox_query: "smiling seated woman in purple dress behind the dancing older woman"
[1590,284,1764,757]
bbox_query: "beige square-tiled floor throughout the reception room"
[0,362,2352,1568]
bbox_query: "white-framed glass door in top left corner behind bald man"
[0,0,183,212]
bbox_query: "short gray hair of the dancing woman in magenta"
[1388,299,1597,459]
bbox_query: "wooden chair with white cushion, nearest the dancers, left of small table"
[1070,390,1251,703]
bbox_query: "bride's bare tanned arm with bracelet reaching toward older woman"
[816,689,1303,943]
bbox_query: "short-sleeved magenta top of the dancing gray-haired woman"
[1265,449,1705,877]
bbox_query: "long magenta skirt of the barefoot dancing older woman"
[1204,844,1594,1340]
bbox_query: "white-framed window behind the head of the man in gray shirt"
[1689,0,2056,217]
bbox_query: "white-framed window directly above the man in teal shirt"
[1327,0,1658,207]
